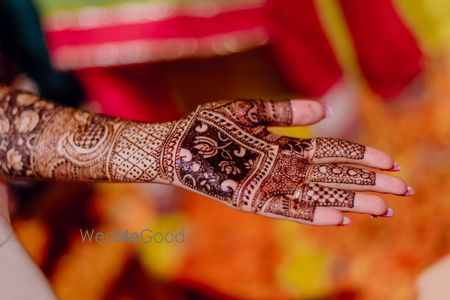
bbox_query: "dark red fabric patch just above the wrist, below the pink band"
[76,65,181,122]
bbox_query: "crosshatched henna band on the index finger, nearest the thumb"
[313,138,366,159]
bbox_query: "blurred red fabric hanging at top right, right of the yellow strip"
[340,0,423,97]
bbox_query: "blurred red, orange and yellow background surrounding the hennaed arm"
[0,0,450,299]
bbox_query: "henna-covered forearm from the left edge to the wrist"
[0,87,175,183]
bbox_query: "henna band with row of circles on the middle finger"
[308,164,376,185]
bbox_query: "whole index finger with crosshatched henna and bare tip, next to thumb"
[309,138,394,170]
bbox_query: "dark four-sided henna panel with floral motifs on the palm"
[175,120,261,203]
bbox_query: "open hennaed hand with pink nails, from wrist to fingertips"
[162,100,412,225]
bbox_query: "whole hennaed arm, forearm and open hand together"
[0,87,410,225]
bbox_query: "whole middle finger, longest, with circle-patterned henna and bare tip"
[306,164,413,196]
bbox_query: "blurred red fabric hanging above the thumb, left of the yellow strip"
[268,0,342,97]
